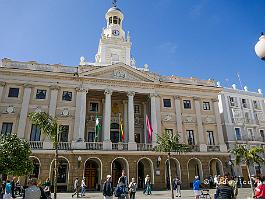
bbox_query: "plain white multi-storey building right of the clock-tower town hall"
[219,84,265,178]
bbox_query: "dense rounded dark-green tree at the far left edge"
[0,134,33,176]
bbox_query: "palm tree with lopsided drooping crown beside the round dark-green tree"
[29,112,60,199]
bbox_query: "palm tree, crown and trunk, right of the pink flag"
[156,131,190,199]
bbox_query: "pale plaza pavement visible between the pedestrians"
[18,188,252,199]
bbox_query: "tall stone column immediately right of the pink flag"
[150,93,158,147]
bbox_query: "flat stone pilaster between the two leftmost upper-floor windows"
[17,84,32,139]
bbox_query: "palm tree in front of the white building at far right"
[230,144,265,193]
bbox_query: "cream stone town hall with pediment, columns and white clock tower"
[0,5,229,190]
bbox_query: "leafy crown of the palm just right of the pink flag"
[156,131,191,153]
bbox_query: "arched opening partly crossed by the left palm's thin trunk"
[50,157,69,192]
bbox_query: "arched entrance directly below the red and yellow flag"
[111,158,130,187]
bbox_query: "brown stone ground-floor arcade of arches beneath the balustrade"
[27,151,229,191]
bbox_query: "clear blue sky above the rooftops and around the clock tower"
[0,0,265,92]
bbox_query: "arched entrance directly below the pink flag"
[136,158,154,189]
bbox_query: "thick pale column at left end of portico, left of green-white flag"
[74,87,87,148]
